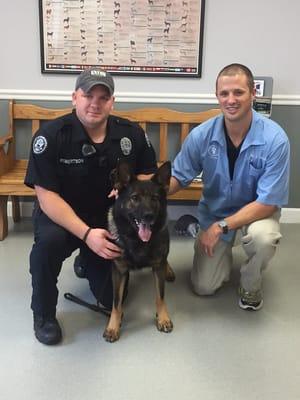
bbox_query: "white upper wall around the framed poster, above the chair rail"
[0,0,300,99]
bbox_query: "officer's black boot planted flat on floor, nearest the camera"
[33,314,62,345]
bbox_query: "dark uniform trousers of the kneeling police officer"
[30,207,113,316]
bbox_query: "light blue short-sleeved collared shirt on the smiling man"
[172,110,290,240]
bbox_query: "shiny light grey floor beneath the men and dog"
[0,220,300,400]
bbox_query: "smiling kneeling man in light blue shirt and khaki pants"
[170,64,290,310]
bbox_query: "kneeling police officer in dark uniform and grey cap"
[25,68,156,345]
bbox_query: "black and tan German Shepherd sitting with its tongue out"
[103,161,175,342]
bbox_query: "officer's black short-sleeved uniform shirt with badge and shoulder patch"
[25,111,157,226]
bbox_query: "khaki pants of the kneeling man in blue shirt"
[191,211,281,295]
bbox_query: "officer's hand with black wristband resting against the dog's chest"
[86,228,122,260]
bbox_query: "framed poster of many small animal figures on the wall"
[39,0,205,77]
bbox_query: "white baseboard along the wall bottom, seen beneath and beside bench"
[8,202,300,224]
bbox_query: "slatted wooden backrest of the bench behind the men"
[9,101,220,162]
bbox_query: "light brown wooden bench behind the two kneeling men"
[0,100,220,240]
